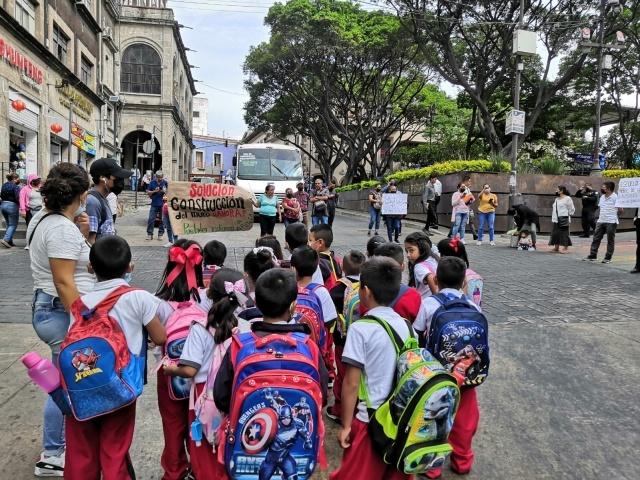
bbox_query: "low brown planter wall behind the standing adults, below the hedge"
[339,173,635,233]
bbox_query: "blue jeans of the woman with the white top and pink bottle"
[31,290,69,455]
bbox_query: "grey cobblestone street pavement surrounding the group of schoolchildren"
[0,211,640,480]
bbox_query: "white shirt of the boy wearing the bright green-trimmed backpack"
[342,307,409,423]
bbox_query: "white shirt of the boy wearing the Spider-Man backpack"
[81,278,161,355]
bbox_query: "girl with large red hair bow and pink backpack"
[156,239,207,480]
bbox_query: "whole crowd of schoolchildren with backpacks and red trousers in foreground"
[30,218,488,480]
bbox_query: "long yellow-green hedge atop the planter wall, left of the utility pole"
[336,160,511,192]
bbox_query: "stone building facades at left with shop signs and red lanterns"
[0,0,195,179]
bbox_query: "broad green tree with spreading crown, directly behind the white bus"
[244,0,436,182]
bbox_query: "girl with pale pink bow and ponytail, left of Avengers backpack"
[163,268,246,480]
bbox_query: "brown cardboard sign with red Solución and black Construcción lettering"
[167,182,253,235]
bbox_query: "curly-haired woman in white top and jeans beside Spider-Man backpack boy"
[27,163,94,476]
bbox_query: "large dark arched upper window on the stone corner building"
[120,43,162,95]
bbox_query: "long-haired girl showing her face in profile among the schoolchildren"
[404,232,438,300]
